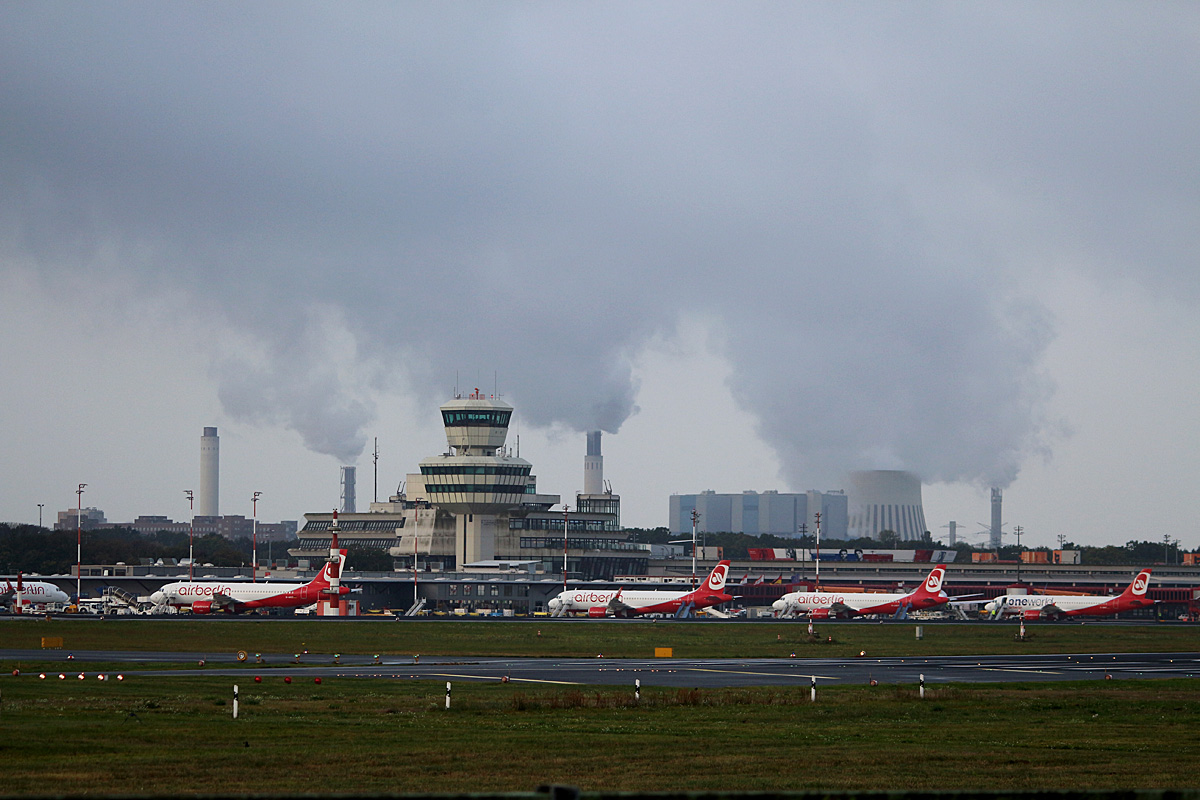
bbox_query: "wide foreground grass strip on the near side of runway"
[0,675,1200,795]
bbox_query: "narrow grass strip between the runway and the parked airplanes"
[9,619,1200,670]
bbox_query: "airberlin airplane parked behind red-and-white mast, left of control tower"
[150,551,350,614]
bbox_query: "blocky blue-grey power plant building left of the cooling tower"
[670,491,847,539]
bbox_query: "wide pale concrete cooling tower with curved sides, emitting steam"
[846,469,926,542]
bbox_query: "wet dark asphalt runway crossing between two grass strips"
[0,650,1200,688]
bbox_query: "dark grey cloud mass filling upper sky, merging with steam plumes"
[0,2,1200,485]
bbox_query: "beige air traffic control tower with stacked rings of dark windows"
[421,389,533,569]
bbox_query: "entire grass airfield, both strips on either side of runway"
[0,619,1200,795]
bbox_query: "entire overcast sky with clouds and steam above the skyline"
[0,1,1200,548]
